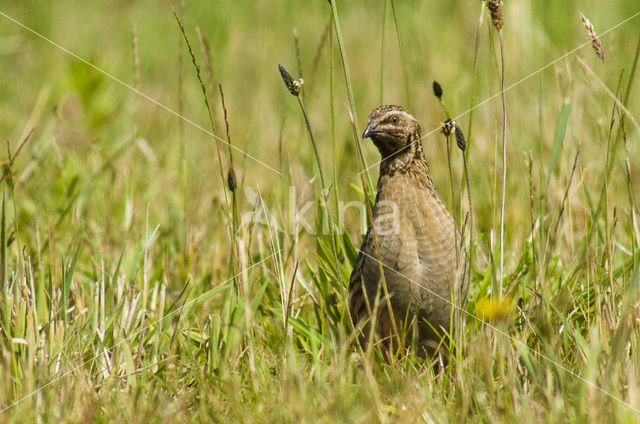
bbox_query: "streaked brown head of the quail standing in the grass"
[362,105,420,158]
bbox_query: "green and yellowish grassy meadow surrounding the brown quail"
[0,0,640,422]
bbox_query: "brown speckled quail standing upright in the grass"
[349,105,466,355]
